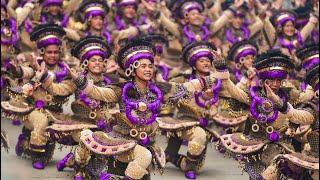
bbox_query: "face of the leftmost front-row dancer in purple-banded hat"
[43,45,60,66]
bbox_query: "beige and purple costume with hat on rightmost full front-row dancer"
[220,50,314,179]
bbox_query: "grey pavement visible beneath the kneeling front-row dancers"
[1,118,249,180]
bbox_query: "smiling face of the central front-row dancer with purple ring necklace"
[135,59,154,81]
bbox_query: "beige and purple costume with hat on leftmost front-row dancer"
[1,24,74,169]
